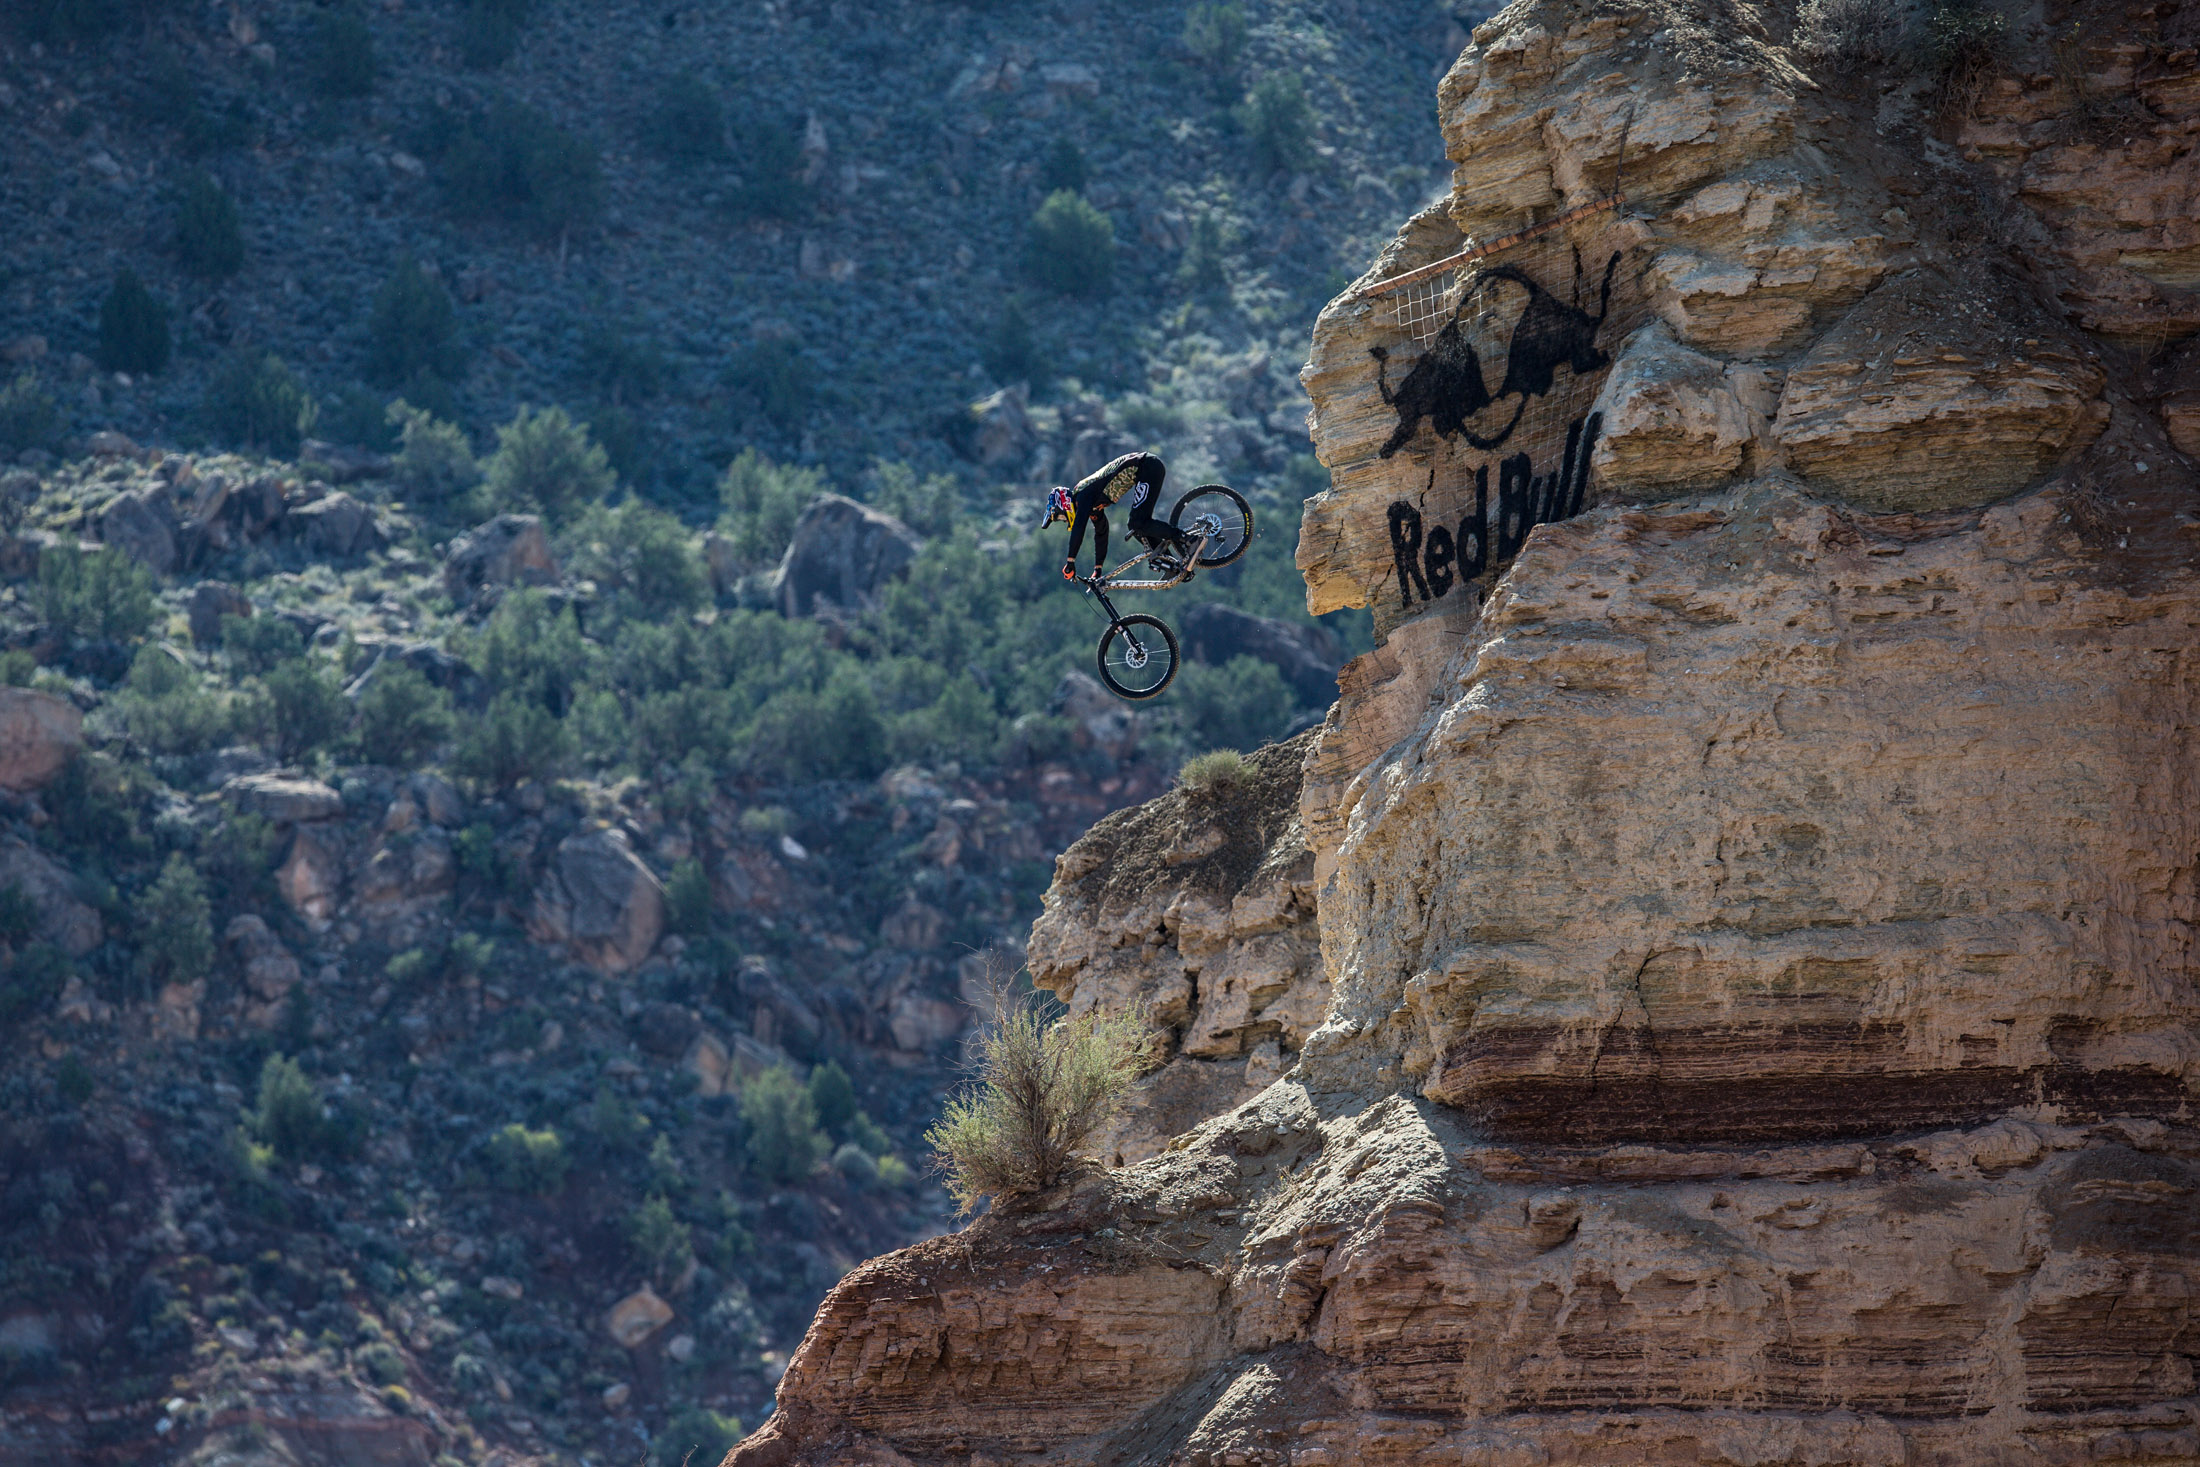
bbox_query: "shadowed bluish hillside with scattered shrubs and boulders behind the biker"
[0,0,1513,1467]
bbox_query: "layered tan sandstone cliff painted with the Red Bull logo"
[728,0,2200,1467]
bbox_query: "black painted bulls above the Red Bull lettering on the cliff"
[1368,251,1619,457]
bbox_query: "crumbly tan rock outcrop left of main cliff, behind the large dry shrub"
[1025,735,1329,1161]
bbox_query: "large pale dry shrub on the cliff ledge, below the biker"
[924,988,1151,1212]
